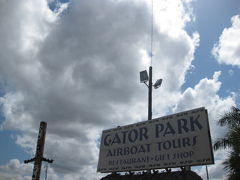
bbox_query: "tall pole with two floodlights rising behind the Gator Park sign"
[140,66,162,120]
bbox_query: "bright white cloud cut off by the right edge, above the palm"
[212,15,240,67]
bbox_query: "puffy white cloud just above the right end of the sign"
[174,71,235,140]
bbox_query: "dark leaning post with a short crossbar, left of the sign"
[24,121,53,180]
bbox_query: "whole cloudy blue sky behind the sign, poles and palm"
[0,0,240,180]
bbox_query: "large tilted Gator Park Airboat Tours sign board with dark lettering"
[97,108,214,173]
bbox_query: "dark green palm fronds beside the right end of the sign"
[213,107,240,180]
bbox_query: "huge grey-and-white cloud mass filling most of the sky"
[0,0,234,180]
